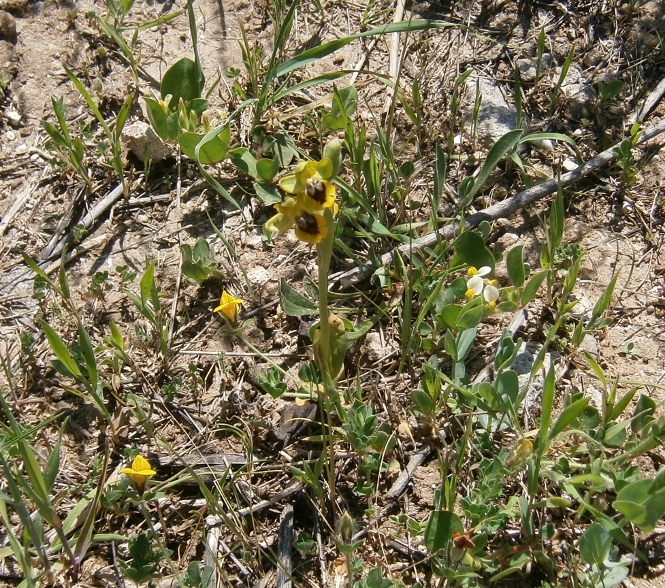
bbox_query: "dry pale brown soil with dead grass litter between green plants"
[0,0,665,588]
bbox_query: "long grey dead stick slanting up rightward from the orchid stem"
[330,120,665,290]
